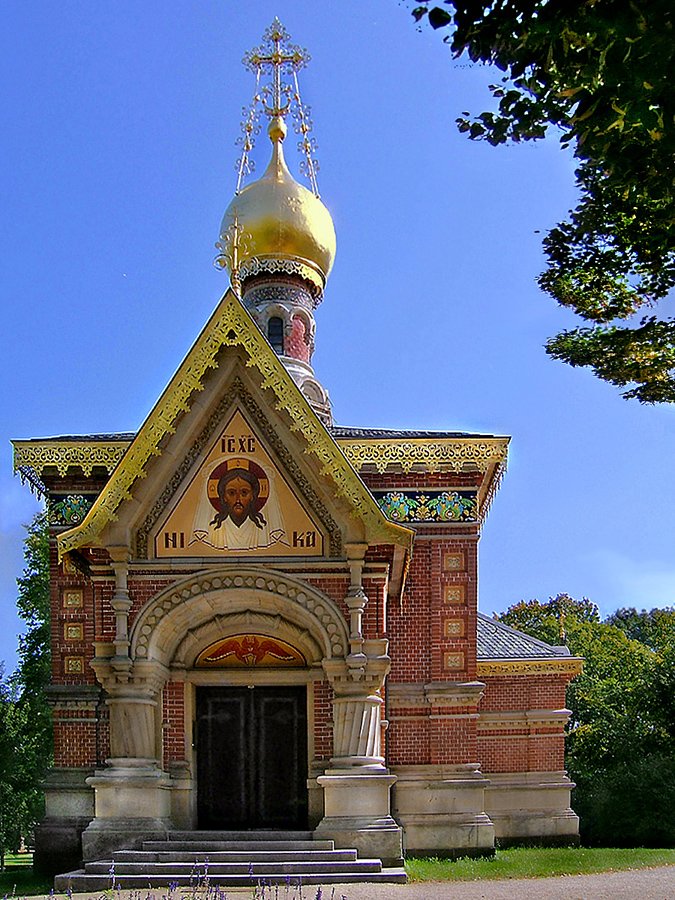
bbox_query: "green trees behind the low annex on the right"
[499,594,675,847]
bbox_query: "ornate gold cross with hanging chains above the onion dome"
[236,18,319,197]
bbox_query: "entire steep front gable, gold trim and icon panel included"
[59,292,412,559]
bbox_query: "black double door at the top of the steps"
[195,685,307,830]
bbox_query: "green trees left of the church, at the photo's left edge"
[0,514,52,864]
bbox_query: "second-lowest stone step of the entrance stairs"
[84,859,382,882]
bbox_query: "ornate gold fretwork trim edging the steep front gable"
[58,291,414,555]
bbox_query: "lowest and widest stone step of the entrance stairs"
[54,868,406,893]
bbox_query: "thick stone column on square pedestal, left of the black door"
[82,642,171,861]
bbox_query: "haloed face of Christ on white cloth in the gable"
[191,457,286,550]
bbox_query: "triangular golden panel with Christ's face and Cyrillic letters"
[155,411,324,557]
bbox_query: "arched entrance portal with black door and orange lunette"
[132,569,348,830]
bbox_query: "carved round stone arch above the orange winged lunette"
[130,566,349,666]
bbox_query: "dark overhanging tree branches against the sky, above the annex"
[413,0,675,403]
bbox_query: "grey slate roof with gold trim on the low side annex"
[476,613,582,676]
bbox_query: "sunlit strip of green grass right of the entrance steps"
[405,847,675,881]
